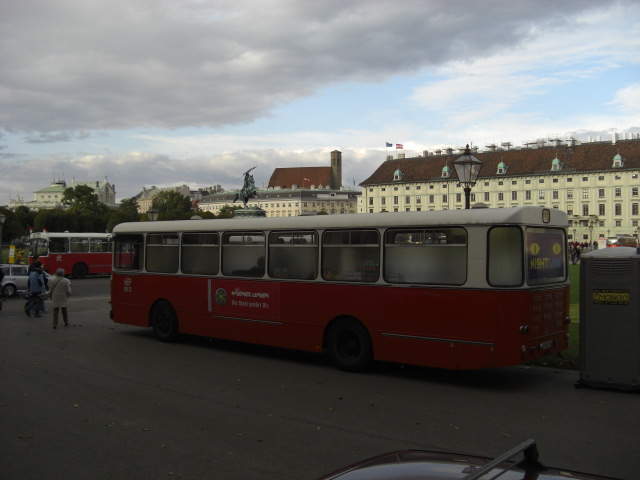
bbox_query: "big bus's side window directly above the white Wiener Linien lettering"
[222,232,265,278]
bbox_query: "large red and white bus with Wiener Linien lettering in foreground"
[111,207,570,371]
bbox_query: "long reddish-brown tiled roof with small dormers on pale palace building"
[360,139,640,186]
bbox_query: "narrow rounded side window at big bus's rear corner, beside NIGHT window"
[487,227,524,287]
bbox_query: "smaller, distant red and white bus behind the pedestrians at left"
[29,232,112,278]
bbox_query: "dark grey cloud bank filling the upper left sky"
[0,0,601,133]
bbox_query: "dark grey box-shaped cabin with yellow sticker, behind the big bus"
[577,247,640,390]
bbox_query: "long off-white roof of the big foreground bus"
[113,206,568,234]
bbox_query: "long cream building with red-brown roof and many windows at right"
[359,135,640,243]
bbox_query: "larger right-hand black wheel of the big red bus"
[327,318,373,372]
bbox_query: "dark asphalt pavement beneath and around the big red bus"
[0,278,640,480]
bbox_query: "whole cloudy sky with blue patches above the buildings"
[0,0,640,205]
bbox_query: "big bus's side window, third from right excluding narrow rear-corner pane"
[269,232,318,280]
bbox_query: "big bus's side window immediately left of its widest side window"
[322,230,380,282]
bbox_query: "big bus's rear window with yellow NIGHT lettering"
[525,228,567,285]
